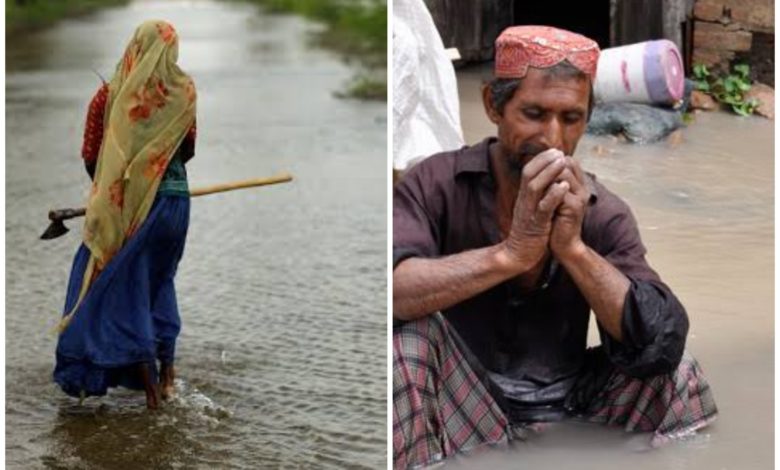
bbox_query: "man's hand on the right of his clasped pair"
[550,158,590,260]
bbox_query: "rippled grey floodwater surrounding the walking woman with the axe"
[5,0,387,469]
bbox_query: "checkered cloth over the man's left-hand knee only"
[393,313,508,468]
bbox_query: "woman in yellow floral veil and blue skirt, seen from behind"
[54,21,196,408]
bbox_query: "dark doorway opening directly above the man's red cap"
[513,0,611,49]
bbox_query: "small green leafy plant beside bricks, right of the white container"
[693,64,758,116]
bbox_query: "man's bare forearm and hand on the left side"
[393,150,570,321]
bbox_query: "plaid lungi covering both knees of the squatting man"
[393,313,717,468]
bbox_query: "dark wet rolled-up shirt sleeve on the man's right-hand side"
[600,201,688,377]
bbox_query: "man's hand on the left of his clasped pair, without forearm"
[504,149,571,273]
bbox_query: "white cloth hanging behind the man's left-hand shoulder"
[393,0,464,170]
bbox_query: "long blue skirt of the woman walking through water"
[54,194,190,397]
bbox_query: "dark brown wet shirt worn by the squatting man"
[393,139,688,414]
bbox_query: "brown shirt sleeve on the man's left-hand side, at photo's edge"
[393,165,440,269]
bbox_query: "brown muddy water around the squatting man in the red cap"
[445,68,774,470]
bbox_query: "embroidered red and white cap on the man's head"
[495,26,599,82]
